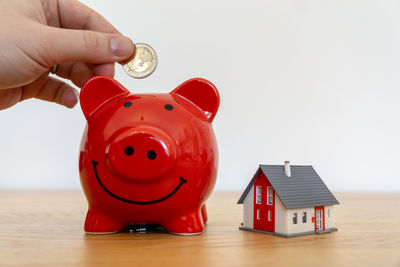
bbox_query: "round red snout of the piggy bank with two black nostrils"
[106,127,176,182]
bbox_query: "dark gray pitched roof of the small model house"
[238,165,339,209]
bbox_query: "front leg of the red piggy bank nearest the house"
[162,210,204,235]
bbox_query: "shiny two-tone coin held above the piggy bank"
[124,44,158,79]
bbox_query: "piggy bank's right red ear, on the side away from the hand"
[171,78,219,122]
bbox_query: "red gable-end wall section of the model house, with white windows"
[253,172,275,233]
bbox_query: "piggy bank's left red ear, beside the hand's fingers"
[79,75,129,119]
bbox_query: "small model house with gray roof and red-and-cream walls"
[238,161,339,237]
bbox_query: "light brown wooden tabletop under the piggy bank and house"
[0,191,400,267]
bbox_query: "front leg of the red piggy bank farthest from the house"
[85,209,126,234]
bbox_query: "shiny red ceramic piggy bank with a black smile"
[79,76,219,235]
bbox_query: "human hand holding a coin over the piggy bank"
[0,0,135,110]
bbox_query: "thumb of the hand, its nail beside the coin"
[42,27,135,66]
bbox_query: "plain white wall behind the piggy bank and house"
[0,0,400,191]
